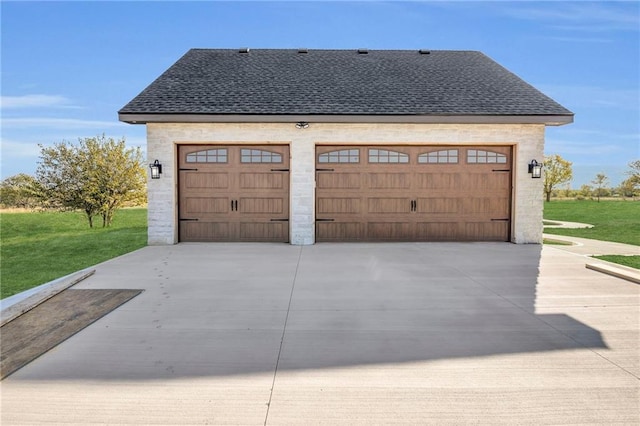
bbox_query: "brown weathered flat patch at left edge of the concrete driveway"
[0,289,143,379]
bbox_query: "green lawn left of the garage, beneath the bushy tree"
[0,208,147,298]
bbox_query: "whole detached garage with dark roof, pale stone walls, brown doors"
[119,49,573,244]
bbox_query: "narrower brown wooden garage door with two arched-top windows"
[178,145,289,242]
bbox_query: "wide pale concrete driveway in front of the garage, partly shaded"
[1,243,640,425]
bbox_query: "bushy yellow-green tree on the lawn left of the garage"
[36,135,146,227]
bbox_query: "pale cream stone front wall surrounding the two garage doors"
[147,122,544,245]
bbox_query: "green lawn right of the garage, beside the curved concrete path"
[544,200,640,246]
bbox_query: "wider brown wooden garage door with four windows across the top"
[316,146,512,242]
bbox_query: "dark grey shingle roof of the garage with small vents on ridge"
[119,49,572,121]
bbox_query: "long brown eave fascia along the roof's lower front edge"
[118,112,573,126]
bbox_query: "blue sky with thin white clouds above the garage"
[0,0,640,188]
